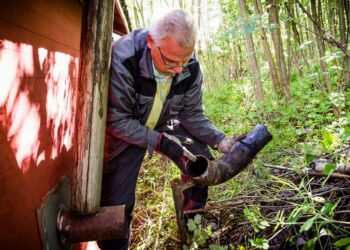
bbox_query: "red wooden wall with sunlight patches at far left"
[0,0,82,246]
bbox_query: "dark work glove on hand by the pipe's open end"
[157,133,188,173]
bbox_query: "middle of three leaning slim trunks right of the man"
[253,0,282,93]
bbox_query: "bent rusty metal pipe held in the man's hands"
[186,124,272,186]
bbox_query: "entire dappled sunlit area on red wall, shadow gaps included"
[0,40,79,173]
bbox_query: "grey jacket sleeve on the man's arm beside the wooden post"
[107,46,160,153]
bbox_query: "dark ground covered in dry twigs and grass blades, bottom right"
[167,170,350,249]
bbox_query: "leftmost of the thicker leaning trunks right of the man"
[239,0,263,101]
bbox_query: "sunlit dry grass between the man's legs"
[131,155,180,249]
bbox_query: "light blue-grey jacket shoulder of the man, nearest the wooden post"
[112,29,148,60]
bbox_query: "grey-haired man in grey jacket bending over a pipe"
[99,9,233,249]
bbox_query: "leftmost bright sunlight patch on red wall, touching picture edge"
[0,40,40,172]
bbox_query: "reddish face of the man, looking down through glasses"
[147,34,194,75]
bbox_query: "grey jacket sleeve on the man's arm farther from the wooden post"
[179,66,225,148]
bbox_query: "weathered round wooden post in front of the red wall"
[71,0,114,215]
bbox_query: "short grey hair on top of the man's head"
[150,9,198,48]
